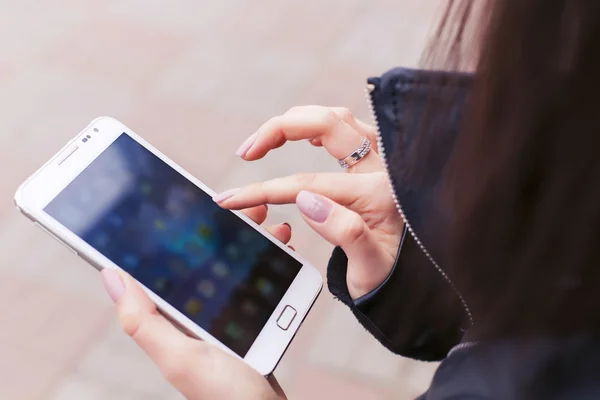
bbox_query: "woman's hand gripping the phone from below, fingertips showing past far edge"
[102,206,291,400]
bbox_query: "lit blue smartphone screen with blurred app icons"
[45,133,302,357]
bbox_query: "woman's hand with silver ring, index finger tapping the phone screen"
[214,106,404,299]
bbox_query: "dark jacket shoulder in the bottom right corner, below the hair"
[423,335,600,400]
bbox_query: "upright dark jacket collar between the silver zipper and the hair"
[368,68,473,260]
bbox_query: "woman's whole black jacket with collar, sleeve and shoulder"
[327,68,600,400]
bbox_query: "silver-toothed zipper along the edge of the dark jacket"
[365,84,473,326]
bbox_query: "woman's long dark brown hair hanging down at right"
[425,0,600,338]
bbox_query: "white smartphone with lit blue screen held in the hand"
[15,117,323,376]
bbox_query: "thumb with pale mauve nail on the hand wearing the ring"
[296,191,394,299]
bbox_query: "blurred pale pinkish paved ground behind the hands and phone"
[0,0,444,400]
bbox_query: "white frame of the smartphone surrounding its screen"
[15,117,323,376]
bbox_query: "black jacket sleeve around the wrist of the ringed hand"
[327,229,467,361]
